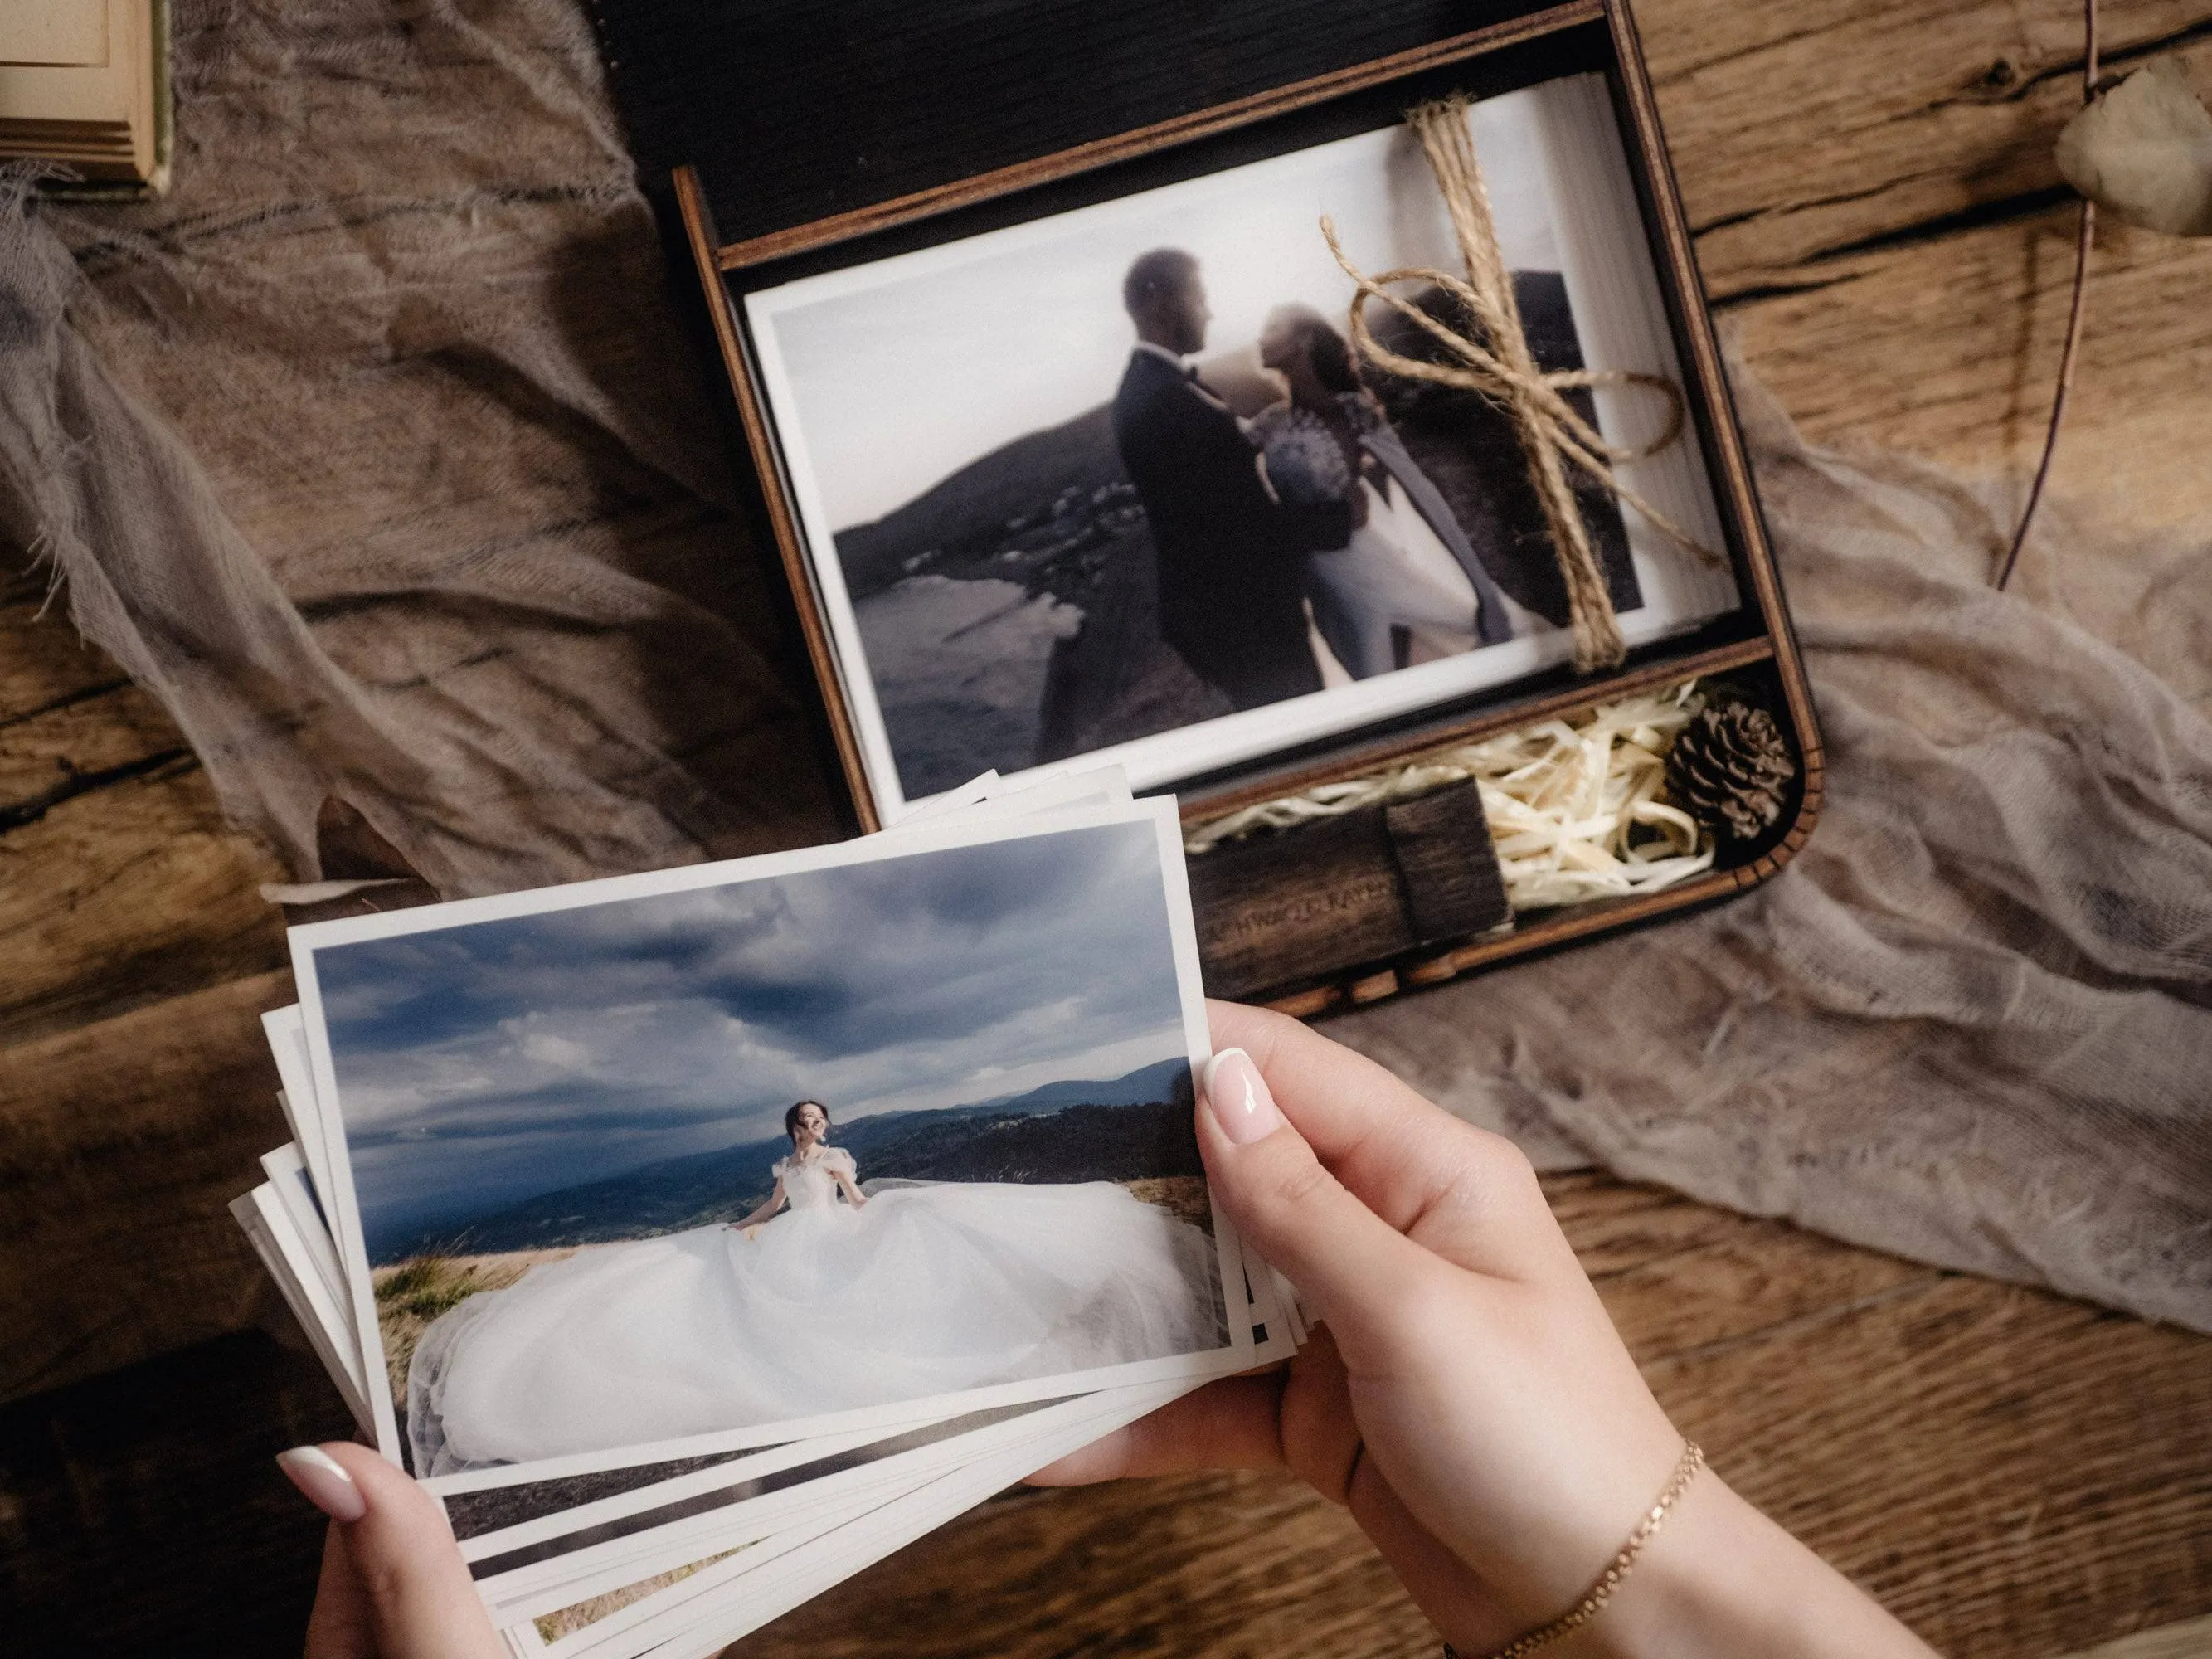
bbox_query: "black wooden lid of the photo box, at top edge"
[593,0,1558,243]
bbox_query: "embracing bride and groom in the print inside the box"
[1113,248,1513,708]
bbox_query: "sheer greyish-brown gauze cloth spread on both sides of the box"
[12,0,2212,1330]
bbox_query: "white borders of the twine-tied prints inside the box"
[743,73,1743,823]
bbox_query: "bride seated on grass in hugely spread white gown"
[407,1102,1223,1476]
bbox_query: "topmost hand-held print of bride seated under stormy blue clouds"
[294,803,1252,1480]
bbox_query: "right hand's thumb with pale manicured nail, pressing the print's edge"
[1199,1048,1440,1350]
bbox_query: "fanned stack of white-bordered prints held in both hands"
[232,767,1305,1659]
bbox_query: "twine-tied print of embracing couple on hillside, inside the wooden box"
[746,75,1738,807]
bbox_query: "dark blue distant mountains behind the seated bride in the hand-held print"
[376,1058,1201,1263]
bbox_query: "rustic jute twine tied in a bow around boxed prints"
[1320,97,1721,673]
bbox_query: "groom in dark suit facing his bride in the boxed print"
[1113,248,1354,708]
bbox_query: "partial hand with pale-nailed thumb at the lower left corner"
[276,1440,507,1659]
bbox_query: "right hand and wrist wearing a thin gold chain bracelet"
[1035,1002,1927,1659]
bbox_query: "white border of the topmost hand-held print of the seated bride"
[289,799,1254,1486]
